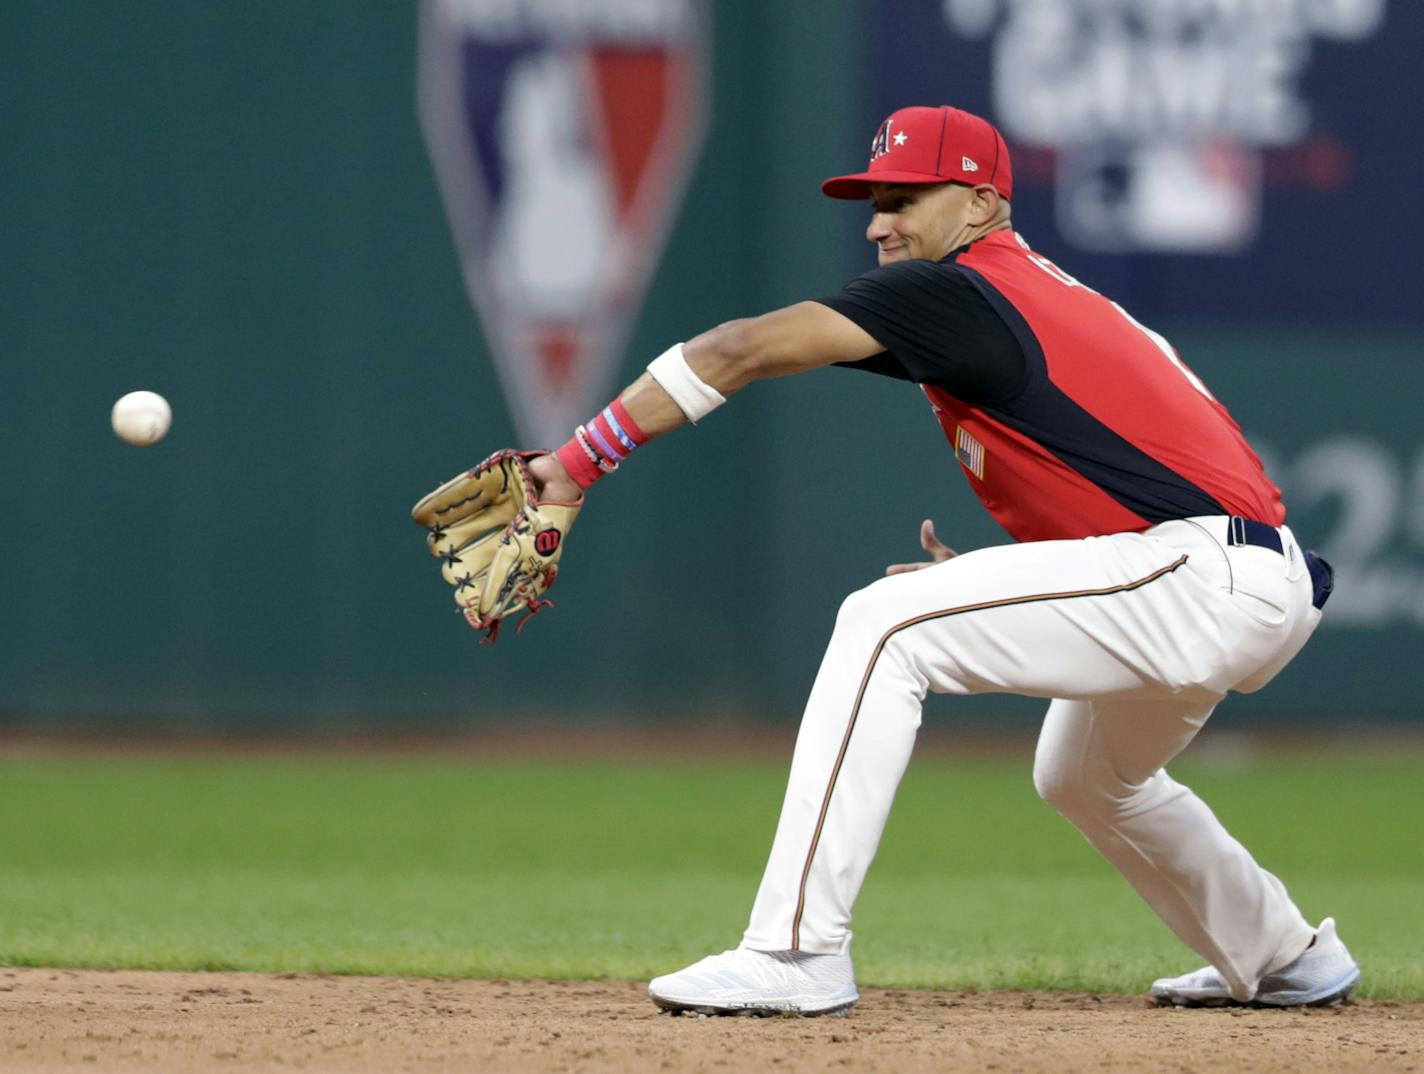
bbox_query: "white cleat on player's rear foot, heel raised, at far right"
[1152,917,1360,1007]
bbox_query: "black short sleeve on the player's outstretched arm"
[817,255,1028,403]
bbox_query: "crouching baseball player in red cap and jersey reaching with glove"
[417,107,1360,1014]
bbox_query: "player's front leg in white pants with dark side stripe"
[743,534,1247,953]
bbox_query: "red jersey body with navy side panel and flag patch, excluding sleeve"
[924,231,1286,541]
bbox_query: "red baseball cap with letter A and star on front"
[820,104,1014,201]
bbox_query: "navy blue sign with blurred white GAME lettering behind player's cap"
[873,0,1424,323]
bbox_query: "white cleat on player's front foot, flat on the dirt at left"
[648,947,860,1014]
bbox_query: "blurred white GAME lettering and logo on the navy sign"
[944,0,1384,252]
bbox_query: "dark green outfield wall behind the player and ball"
[0,0,1424,728]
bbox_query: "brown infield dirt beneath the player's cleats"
[0,969,1424,1074]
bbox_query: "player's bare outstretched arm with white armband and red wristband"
[530,302,884,500]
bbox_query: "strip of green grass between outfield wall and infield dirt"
[0,752,1424,999]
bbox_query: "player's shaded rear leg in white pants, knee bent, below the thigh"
[1034,689,1314,1000]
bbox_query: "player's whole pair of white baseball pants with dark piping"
[743,516,1320,1001]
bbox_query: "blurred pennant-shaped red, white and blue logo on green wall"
[419,0,709,446]
